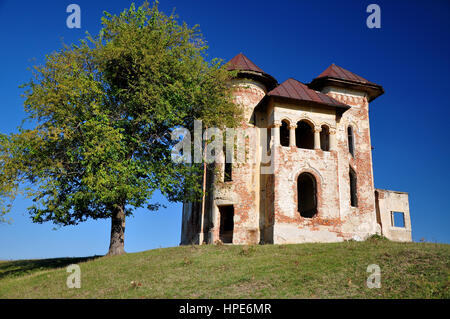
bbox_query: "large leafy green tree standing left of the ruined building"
[0,2,242,255]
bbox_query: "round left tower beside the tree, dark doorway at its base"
[181,53,277,244]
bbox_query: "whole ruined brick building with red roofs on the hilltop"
[181,54,411,244]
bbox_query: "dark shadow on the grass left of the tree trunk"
[0,256,103,279]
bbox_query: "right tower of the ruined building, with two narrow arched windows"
[309,64,384,238]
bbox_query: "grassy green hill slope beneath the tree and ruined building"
[0,239,450,298]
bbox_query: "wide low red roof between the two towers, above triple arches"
[267,78,349,108]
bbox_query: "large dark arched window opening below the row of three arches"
[297,173,317,218]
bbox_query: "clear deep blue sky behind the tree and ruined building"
[0,0,450,259]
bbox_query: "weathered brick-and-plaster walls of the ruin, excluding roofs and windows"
[181,58,411,244]
